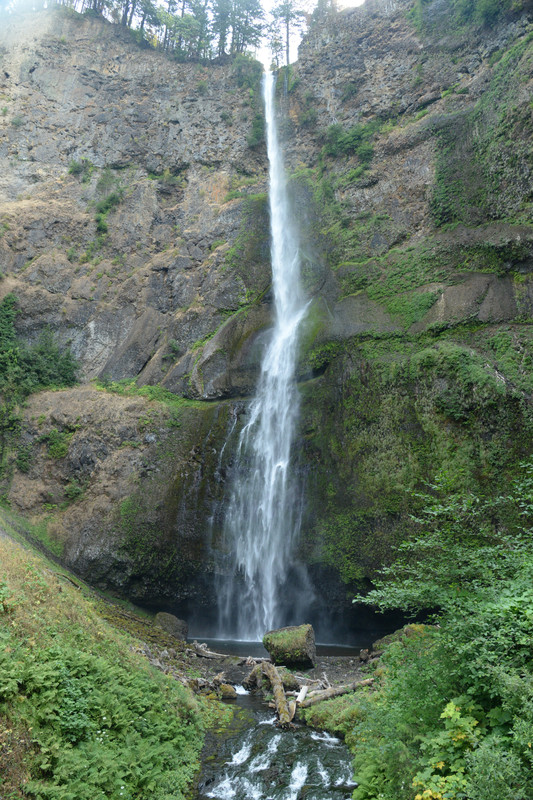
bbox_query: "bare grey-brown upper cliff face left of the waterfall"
[0,9,269,398]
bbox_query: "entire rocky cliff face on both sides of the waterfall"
[0,0,533,620]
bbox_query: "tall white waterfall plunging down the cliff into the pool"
[220,72,306,640]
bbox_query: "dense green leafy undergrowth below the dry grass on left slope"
[0,637,200,800]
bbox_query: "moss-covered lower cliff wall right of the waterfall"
[301,323,533,586]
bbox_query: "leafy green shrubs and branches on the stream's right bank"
[340,460,533,800]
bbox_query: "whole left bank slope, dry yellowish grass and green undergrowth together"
[0,528,206,800]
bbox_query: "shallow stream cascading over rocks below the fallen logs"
[196,688,356,800]
